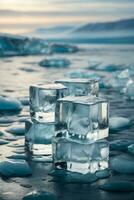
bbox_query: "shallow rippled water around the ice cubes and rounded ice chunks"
[0,45,134,200]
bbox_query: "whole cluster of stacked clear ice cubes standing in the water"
[25,79,109,173]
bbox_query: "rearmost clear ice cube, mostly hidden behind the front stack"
[56,78,99,96]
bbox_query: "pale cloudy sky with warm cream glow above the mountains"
[0,0,134,33]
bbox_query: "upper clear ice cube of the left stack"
[29,84,68,122]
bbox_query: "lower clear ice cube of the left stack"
[25,120,54,155]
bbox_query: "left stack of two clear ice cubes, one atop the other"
[25,83,68,156]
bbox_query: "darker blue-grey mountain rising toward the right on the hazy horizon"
[73,18,134,33]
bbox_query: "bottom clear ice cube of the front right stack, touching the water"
[53,137,109,173]
